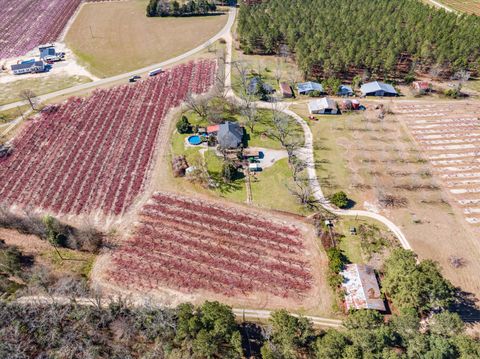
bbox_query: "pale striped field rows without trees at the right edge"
[395,104,480,224]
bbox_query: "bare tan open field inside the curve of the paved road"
[65,0,228,77]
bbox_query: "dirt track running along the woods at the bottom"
[16,296,342,328]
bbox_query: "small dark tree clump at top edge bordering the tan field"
[147,0,217,17]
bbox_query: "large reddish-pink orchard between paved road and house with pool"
[0,60,216,215]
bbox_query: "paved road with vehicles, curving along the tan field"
[0,7,237,111]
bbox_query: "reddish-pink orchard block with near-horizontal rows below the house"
[107,193,328,314]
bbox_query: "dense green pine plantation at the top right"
[238,0,480,78]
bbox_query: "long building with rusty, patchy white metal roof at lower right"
[340,264,385,311]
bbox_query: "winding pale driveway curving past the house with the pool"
[225,26,412,249]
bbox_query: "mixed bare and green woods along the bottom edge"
[0,249,480,359]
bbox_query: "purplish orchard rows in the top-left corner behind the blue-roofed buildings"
[0,0,81,59]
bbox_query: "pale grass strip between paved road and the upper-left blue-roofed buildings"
[0,75,92,105]
